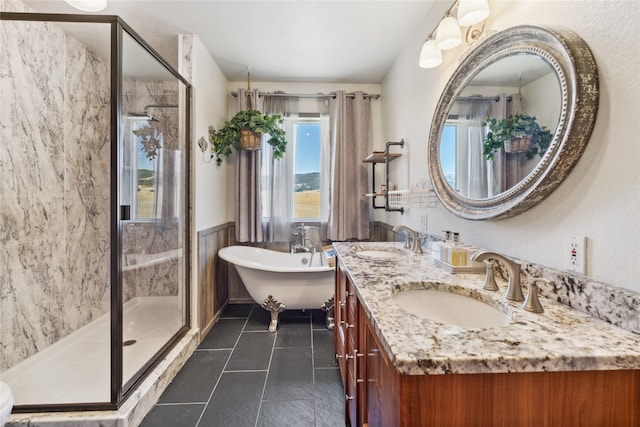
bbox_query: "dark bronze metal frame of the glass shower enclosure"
[0,11,192,413]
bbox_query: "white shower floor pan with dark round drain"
[2,297,182,405]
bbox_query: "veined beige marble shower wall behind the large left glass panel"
[0,4,110,370]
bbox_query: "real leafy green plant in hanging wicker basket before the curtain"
[209,109,287,166]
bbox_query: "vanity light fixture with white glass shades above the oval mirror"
[418,0,489,68]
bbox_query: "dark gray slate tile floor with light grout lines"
[141,304,344,427]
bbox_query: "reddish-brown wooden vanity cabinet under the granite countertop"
[335,263,640,427]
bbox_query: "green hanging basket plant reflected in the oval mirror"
[482,114,553,160]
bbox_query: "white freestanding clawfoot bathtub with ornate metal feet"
[218,246,334,332]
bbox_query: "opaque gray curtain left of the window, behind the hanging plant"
[235,89,264,242]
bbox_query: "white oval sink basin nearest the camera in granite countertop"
[393,289,511,329]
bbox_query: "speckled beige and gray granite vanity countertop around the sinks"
[334,242,640,375]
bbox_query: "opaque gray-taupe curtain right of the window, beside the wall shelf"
[327,91,371,241]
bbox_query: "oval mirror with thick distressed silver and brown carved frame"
[429,25,599,220]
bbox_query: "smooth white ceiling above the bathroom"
[23,0,438,83]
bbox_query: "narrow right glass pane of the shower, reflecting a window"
[120,29,188,391]
